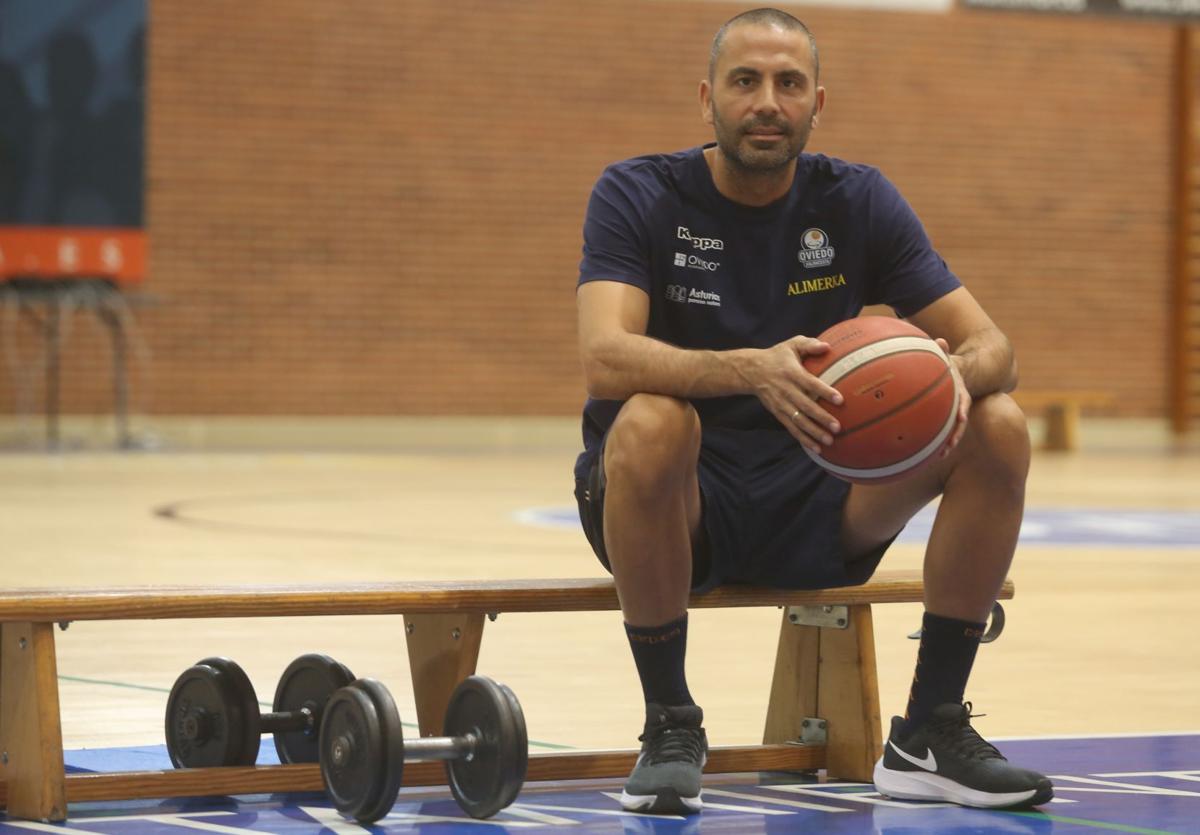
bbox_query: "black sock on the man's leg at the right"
[905,612,986,732]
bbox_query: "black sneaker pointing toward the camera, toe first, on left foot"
[620,704,708,815]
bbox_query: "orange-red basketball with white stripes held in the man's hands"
[804,316,959,483]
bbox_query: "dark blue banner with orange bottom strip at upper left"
[0,0,146,281]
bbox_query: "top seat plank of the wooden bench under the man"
[0,571,1013,623]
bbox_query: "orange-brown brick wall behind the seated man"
[0,0,1172,415]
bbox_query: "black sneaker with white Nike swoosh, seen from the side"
[875,702,1054,809]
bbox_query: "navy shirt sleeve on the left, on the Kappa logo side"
[580,168,650,293]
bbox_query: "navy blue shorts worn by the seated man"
[575,428,892,591]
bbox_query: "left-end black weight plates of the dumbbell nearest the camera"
[320,679,404,823]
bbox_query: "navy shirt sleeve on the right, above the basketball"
[866,174,962,317]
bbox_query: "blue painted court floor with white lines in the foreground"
[0,733,1200,835]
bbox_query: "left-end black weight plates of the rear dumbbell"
[166,663,245,768]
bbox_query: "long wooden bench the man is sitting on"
[0,571,1013,821]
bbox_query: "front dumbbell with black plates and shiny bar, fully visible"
[320,675,529,824]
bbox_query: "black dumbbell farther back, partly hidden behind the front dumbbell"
[166,654,354,768]
